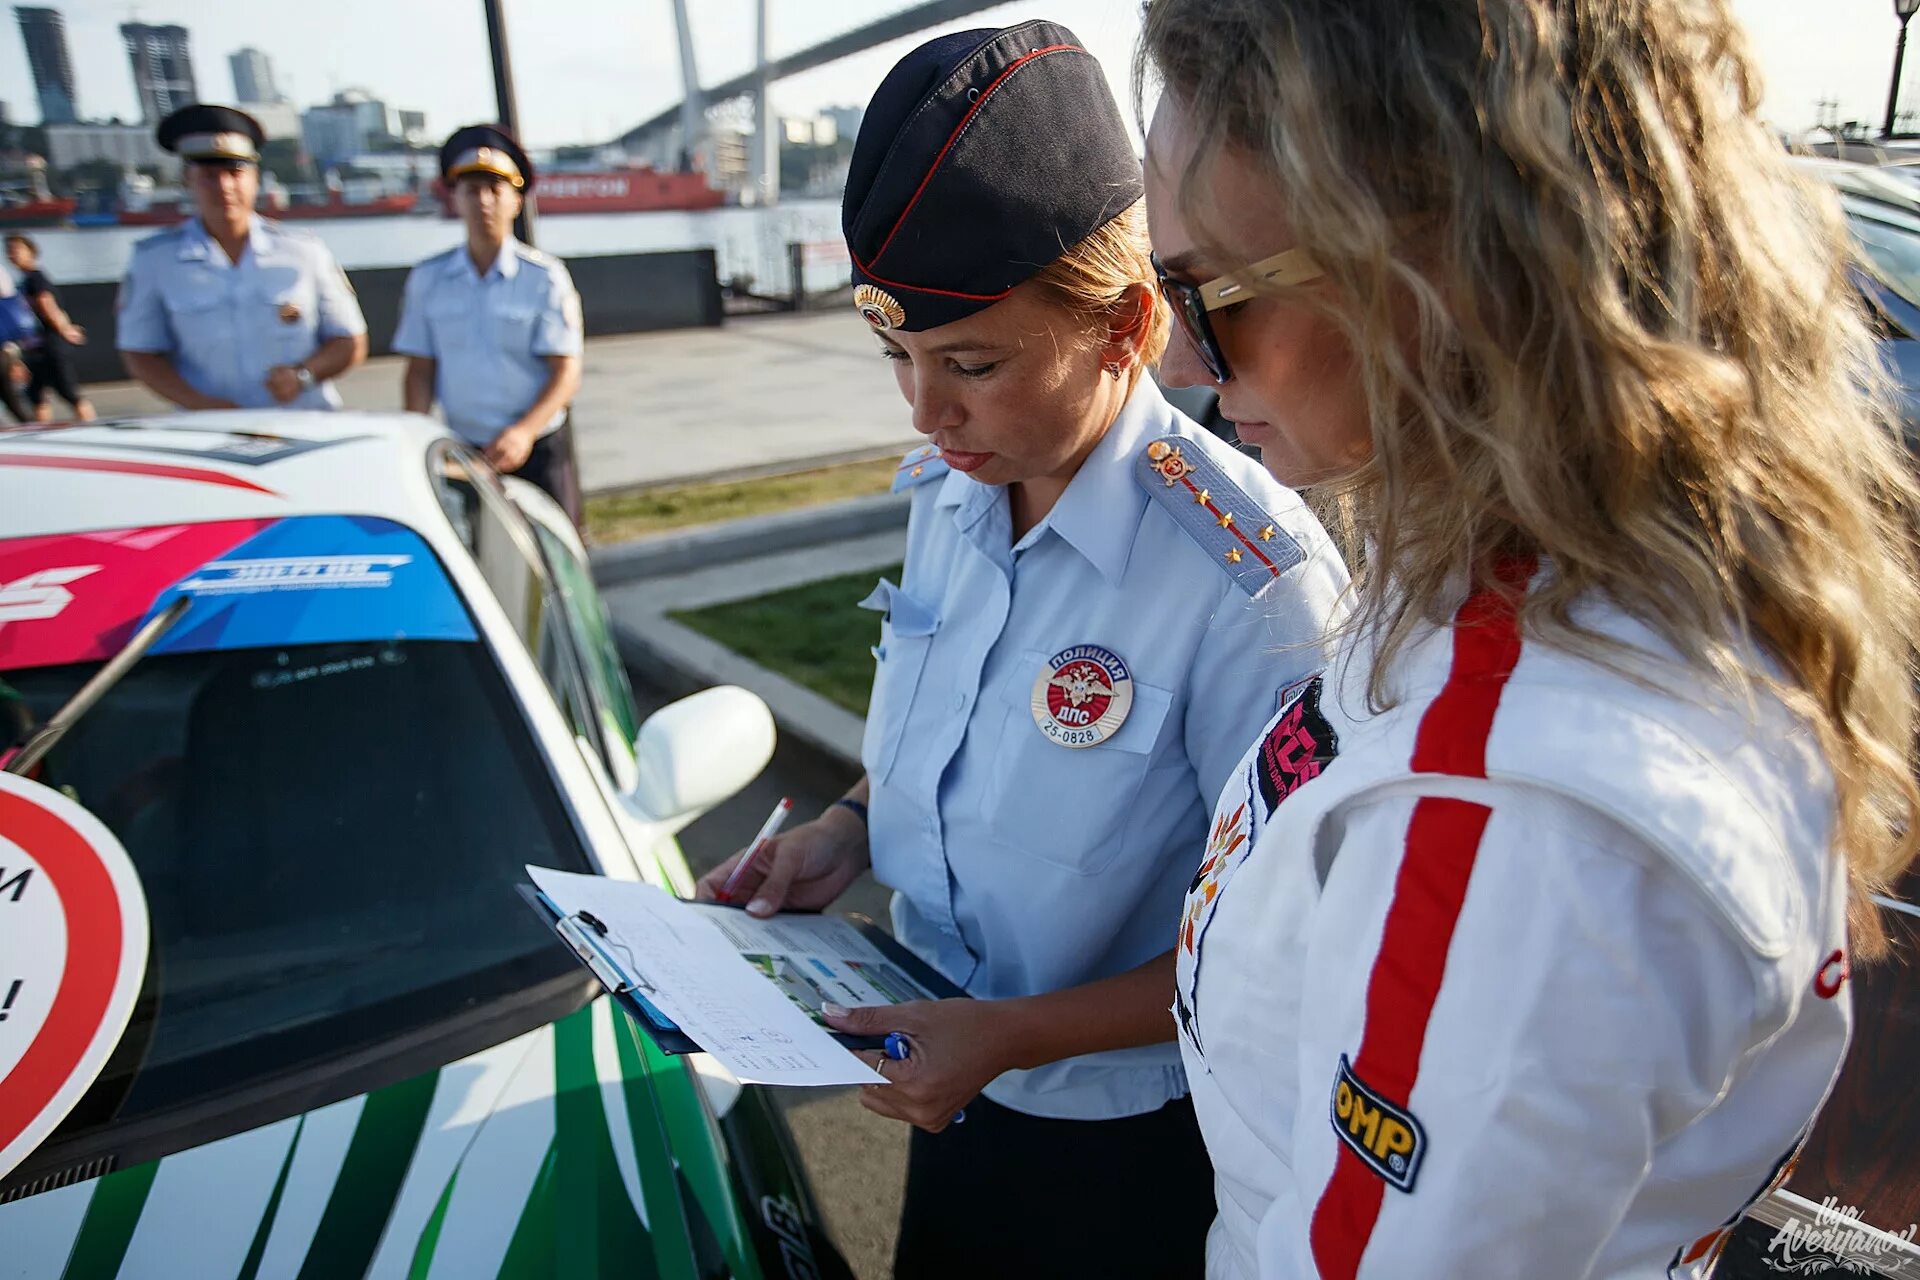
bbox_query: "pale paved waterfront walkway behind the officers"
[72,311,920,493]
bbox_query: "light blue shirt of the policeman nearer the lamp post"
[394,236,582,447]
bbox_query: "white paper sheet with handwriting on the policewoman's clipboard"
[526,867,885,1086]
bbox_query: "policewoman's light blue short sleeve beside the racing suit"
[1183,541,1348,812]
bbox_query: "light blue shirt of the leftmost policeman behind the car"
[113,217,367,409]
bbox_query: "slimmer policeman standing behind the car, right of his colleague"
[394,125,582,524]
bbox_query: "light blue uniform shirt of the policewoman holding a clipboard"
[862,380,1346,1119]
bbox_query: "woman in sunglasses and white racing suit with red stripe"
[1144,0,1920,1280]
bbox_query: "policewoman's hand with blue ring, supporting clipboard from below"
[822,1000,1020,1134]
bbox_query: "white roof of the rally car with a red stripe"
[0,409,453,539]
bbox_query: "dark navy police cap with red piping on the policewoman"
[841,21,1142,332]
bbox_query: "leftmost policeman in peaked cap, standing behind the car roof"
[115,104,367,409]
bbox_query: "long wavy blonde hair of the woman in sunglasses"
[1140,0,1920,956]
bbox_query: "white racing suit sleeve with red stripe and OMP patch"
[1256,789,1786,1280]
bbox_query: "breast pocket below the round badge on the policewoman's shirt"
[981,649,1173,875]
